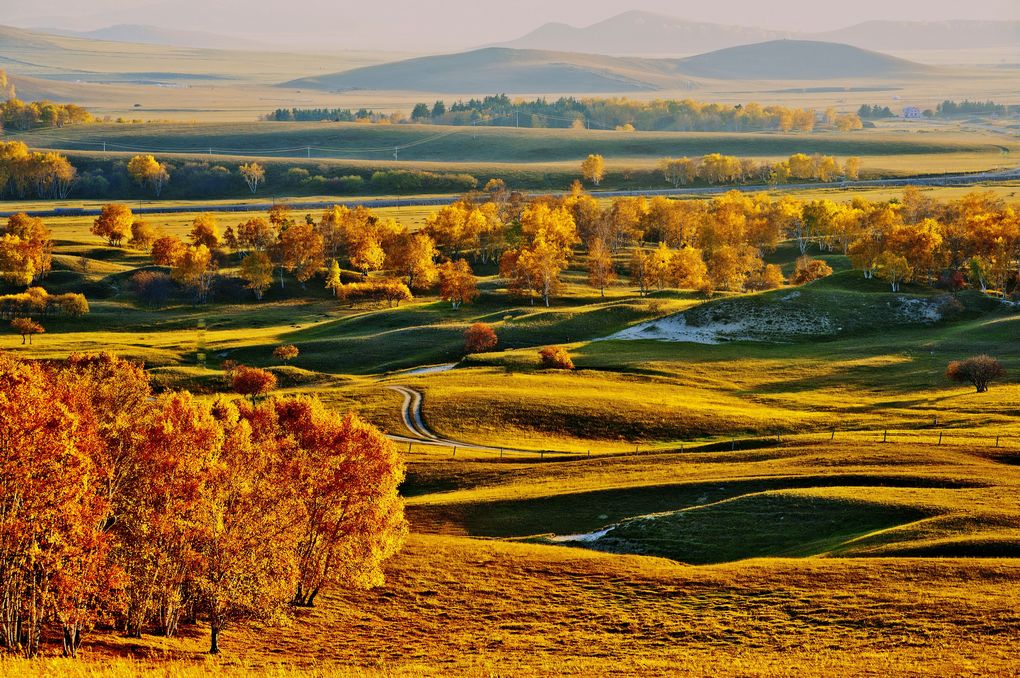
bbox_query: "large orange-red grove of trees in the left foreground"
[0,354,406,657]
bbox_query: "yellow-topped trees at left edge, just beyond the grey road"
[0,142,78,199]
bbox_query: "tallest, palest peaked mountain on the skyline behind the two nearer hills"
[498,10,796,55]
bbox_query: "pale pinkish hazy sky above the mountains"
[7,0,1020,51]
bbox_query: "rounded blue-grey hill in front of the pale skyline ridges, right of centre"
[679,40,937,81]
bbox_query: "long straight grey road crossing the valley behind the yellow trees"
[0,167,1020,217]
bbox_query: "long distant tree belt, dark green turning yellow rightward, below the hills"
[401,95,861,132]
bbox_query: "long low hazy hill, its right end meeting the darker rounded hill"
[283,47,697,94]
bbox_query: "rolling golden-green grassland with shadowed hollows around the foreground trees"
[0,182,1020,677]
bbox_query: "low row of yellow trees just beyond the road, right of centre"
[659,153,861,188]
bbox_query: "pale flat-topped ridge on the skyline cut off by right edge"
[814,20,1020,51]
